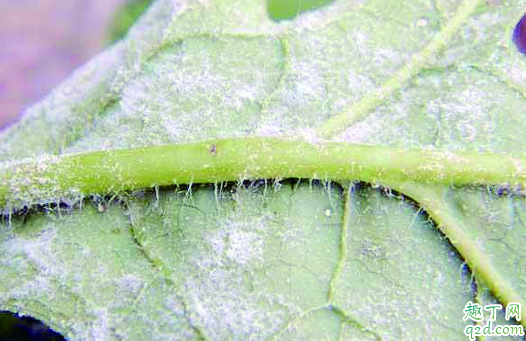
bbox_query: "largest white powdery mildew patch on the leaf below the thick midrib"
[179,207,300,340]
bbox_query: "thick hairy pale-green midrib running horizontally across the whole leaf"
[0,138,526,208]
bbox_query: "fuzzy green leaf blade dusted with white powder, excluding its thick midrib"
[0,0,526,340]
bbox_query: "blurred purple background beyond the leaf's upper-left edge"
[0,0,127,130]
